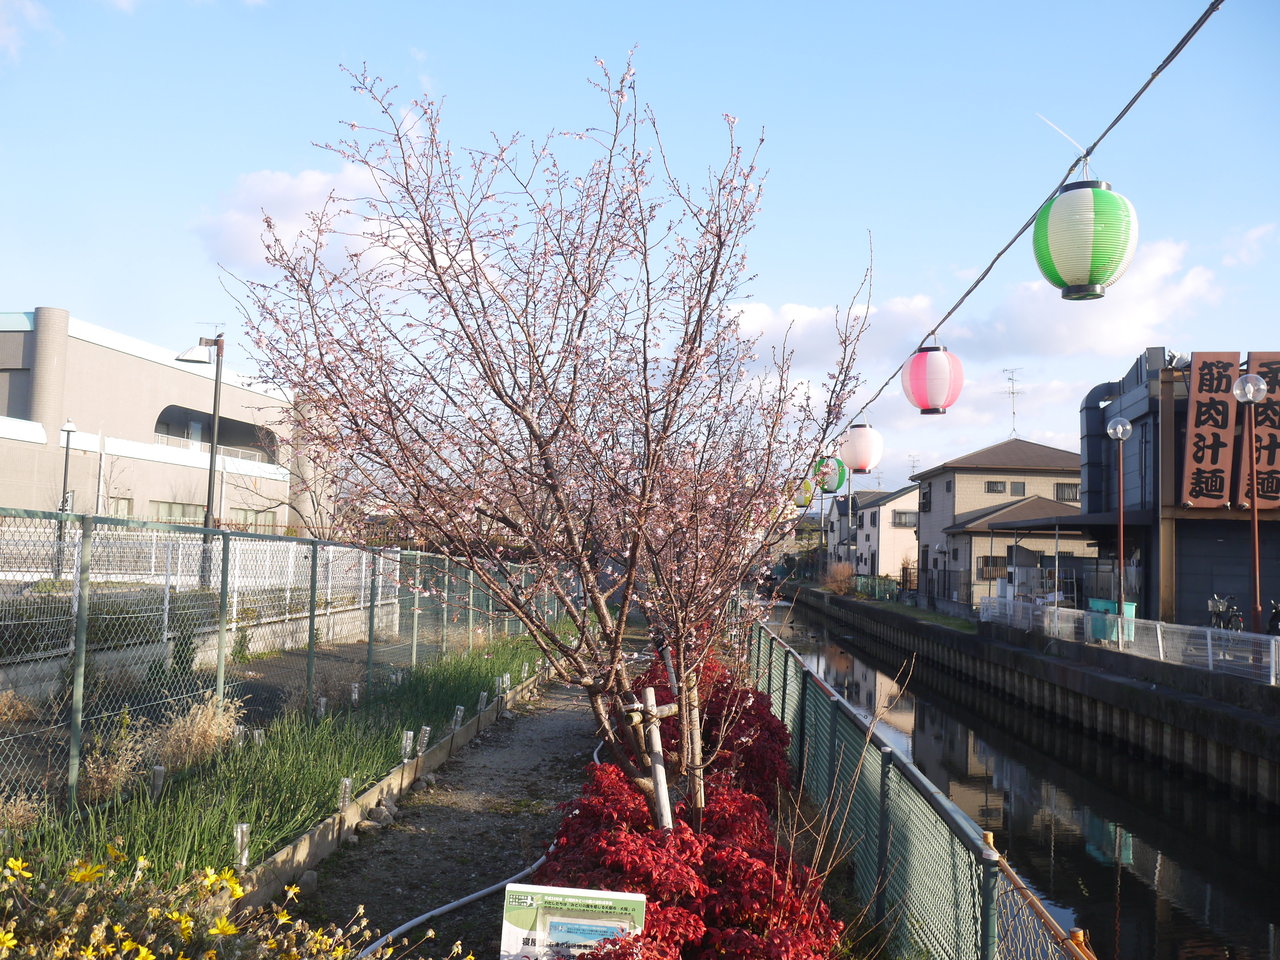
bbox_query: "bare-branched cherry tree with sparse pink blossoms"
[246,63,867,829]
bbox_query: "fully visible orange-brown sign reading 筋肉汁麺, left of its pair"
[1181,352,1240,507]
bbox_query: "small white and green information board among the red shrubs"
[499,883,645,960]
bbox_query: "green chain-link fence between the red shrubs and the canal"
[750,626,1092,960]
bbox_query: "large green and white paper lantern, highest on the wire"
[1032,180,1138,300]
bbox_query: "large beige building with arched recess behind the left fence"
[0,307,313,532]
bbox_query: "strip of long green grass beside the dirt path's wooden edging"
[13,641,536,877]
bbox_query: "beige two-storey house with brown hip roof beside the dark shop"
[911,438,1097,607]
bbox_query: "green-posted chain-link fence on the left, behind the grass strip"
[0,508,554,804]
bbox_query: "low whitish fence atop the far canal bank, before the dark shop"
[980,598,1280,685]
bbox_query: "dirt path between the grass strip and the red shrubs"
[298,684,598,960]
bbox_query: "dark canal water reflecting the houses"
[771,605,1280,960]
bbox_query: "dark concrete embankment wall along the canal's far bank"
[795,588,1280,805]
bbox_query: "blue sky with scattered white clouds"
[0,0,1280,486]
